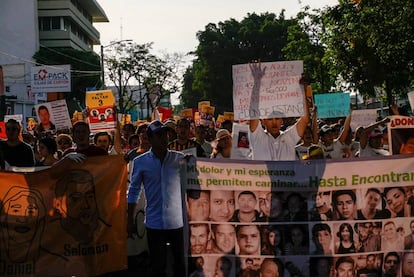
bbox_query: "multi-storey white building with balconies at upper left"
[0,0,109,125]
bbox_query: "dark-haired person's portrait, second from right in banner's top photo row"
[357,188,391,220]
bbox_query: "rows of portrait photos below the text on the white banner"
[185,156,414,277]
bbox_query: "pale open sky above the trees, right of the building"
[94,0,338,53]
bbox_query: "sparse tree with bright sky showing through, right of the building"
[104,43,183,113]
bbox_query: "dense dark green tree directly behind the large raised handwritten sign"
[181,11,295,113]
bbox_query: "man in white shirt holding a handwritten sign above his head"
[246,62,310,161]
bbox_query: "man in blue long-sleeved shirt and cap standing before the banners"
[128,120,186,277]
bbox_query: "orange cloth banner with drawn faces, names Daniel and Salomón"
[0,156,127,276]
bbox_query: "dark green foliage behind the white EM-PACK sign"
[33,47,101,106]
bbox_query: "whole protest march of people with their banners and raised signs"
[0,61,414,277]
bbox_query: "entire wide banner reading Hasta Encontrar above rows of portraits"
[183,155,414,277]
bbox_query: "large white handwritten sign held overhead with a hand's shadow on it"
[233,61,304,120]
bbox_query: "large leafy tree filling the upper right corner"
[322,0,414,105]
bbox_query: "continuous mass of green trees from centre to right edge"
[181,0,414,113]
